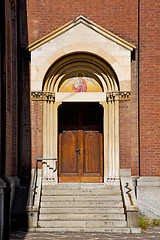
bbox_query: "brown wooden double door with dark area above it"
[58,103,103,182]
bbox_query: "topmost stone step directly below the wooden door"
[42,183,120,190]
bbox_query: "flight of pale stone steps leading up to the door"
[37,183,130,233]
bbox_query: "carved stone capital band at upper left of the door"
[31,91,55,102]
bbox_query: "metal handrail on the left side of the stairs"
[31,157,57,216]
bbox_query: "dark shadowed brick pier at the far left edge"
[1,1,18,177]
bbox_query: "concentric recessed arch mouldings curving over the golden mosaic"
[43,52,119,93]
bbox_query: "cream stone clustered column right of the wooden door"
[103,92,119,183]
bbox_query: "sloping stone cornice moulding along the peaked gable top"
[28,15,136,51]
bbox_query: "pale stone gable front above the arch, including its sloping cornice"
[29,16,135,91]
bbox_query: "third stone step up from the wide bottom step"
[39,213,125,221]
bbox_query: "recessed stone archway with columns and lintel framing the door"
[43,53,119,182]
